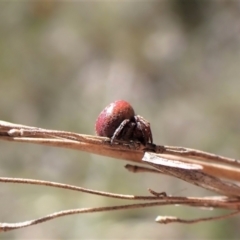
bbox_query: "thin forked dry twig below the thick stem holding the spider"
[0,177,240,232]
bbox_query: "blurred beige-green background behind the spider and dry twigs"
[0,0,240,239]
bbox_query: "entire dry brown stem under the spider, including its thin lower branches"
[0,121,240,231]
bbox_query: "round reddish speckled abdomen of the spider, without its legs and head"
[95,100,135,138]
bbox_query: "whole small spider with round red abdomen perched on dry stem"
[95,100,153,145]
